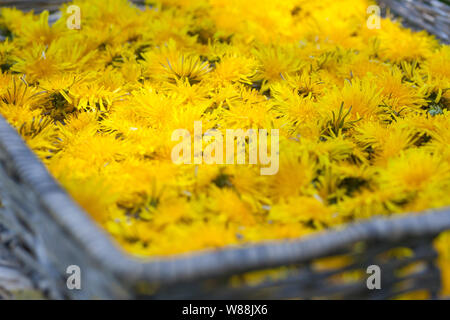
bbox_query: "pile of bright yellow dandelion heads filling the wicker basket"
[0,0,450,294]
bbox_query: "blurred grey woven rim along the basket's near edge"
[0,116,450,283]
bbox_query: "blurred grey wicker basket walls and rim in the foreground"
[0,1,450,299]
